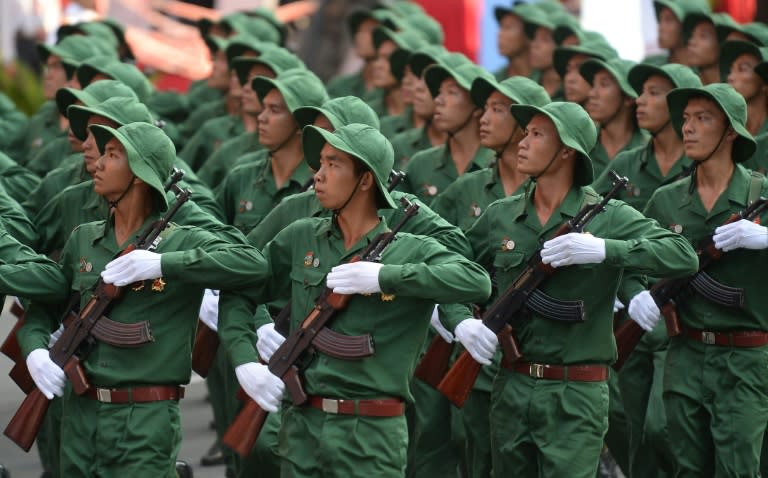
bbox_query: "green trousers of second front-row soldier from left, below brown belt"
[279,406,408,478]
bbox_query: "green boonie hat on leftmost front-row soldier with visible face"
[90,123,176,211]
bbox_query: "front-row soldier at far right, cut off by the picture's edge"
[640,84,768,477]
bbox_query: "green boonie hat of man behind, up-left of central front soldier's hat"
[251,68,329,114]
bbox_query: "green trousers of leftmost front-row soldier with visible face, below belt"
[61,389,181,478]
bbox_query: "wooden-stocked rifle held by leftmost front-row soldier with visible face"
[4,184,192,451]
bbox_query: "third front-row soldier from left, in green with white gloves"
[456,102,696,478]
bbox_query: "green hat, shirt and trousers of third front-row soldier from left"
[456,103,695,478]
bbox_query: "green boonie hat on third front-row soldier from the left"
[510,101,597,186]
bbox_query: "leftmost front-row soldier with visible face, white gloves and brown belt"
[19,123,266,477]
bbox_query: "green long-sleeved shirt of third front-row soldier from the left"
[464,185,697,364]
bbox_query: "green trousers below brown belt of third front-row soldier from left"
[491,369,608,478]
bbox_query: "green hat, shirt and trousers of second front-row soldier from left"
[220,124,490,477]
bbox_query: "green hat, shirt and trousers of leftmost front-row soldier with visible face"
[19,123,265,477]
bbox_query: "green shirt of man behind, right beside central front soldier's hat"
[400,145,494,204]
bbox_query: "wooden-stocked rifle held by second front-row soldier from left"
[223,197,419,456]
